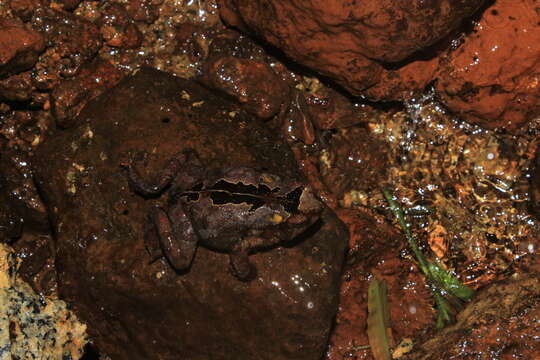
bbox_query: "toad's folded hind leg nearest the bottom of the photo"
[150,204,198,271]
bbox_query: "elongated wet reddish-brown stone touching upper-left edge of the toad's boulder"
[51,60,123,128]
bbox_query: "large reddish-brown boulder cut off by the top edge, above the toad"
[218,0,483,94]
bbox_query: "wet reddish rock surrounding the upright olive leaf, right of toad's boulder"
[326,209,435,360]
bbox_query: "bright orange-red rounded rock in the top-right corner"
[436,0,540,131]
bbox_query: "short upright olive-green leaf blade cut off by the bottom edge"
[367,278,392,360]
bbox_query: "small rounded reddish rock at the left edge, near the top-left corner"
[0,19,45,77]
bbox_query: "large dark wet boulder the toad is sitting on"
[36,69,347,359]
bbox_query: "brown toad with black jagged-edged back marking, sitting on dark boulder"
[123,151,323,280]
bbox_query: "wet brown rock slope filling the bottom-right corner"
[405,272,540,360]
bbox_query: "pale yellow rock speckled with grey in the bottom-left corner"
[0,244,88,360]
